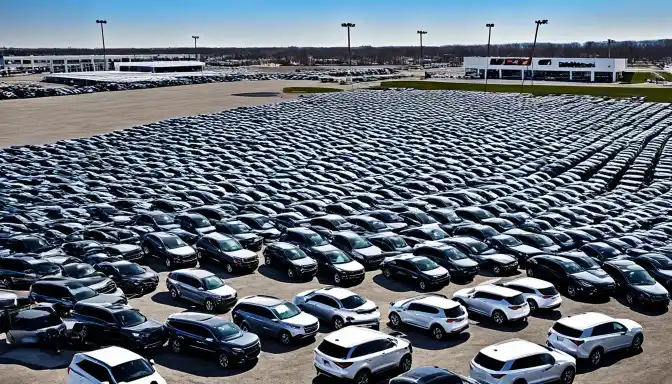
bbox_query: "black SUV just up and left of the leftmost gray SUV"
[95,260,159,295]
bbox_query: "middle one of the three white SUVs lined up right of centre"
[453,282,530,325]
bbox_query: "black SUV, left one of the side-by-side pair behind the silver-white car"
[264,242,317,279]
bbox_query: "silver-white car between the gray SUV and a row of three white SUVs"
[292,287,380,330]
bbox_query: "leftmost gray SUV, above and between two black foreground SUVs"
[166,268,238,312]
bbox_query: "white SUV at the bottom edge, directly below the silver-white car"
[314,326,413,384]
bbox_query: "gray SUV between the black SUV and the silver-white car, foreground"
[231,295,320,345]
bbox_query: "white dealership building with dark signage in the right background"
[463,57,627,83]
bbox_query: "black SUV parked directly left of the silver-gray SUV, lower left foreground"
[165,312,261,368]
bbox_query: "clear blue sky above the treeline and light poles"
[0,0,672,48]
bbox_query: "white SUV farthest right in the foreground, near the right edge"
[546,312,644,366]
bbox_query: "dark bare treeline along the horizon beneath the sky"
[0,39,672,64]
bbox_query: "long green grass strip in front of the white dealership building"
[381,81,672,103]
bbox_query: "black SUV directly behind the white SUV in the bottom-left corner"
[72,303,168,350]
